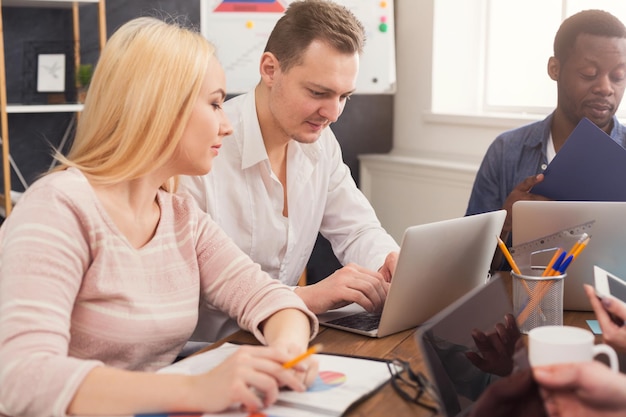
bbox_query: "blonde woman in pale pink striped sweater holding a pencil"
[0,18,317,417]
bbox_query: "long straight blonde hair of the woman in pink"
[55,17,215,191]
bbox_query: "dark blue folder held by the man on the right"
[530,118,626,201]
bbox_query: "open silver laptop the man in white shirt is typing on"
[319,210,506,337]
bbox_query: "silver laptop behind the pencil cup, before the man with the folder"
[512,201,626,311]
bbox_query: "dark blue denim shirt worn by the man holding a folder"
[465,113,626,215]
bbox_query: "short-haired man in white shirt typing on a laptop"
[181,0,399,341]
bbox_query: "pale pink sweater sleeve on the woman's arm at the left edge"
[0,181,101,417]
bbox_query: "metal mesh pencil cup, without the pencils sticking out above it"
[511,268,567,333]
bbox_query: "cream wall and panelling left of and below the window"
[359,0,536,241]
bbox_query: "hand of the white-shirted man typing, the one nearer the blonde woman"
[295,264,388,314]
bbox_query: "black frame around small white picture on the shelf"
[22,41,76,104]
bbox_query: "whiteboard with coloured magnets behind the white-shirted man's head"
[200,0,396,94]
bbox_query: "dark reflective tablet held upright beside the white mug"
[416,275,520,417]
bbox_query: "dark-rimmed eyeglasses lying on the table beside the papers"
[387,359,439,414]
